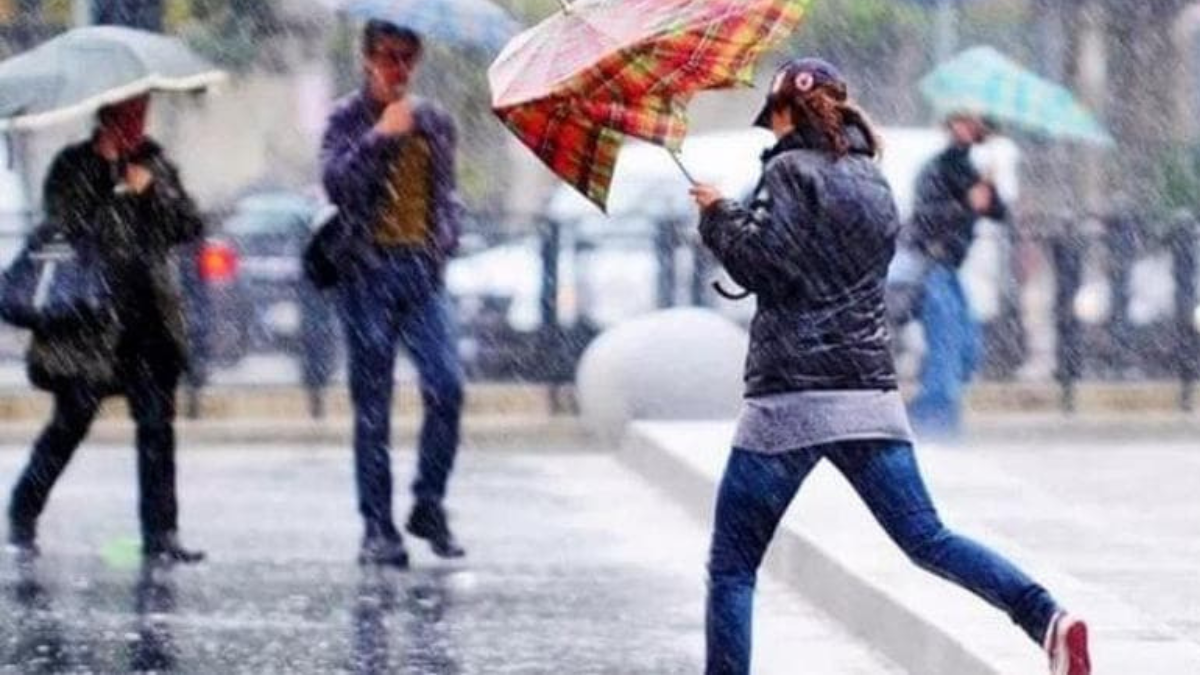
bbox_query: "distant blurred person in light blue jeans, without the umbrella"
[902,114,1008,438]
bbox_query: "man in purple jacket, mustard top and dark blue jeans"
[322,22,464,568]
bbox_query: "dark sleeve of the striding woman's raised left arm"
[700,161,812,294]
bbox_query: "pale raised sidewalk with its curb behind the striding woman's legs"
[622,423,1200,675]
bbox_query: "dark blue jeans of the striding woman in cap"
[706,441,1057,675]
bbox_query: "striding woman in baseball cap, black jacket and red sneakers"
[692,59,1090,675]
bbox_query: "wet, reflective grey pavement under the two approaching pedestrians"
[0,447,898,675]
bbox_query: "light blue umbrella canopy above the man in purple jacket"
[331,0,521,52]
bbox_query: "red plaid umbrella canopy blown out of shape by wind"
[487,0,809,209]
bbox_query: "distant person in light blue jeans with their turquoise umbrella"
[902,46,1112,437]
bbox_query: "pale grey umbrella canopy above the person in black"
[0,26,226,130]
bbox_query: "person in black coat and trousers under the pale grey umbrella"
[8,96,204,562]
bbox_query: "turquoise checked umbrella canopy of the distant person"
[920,47,1112,145]
